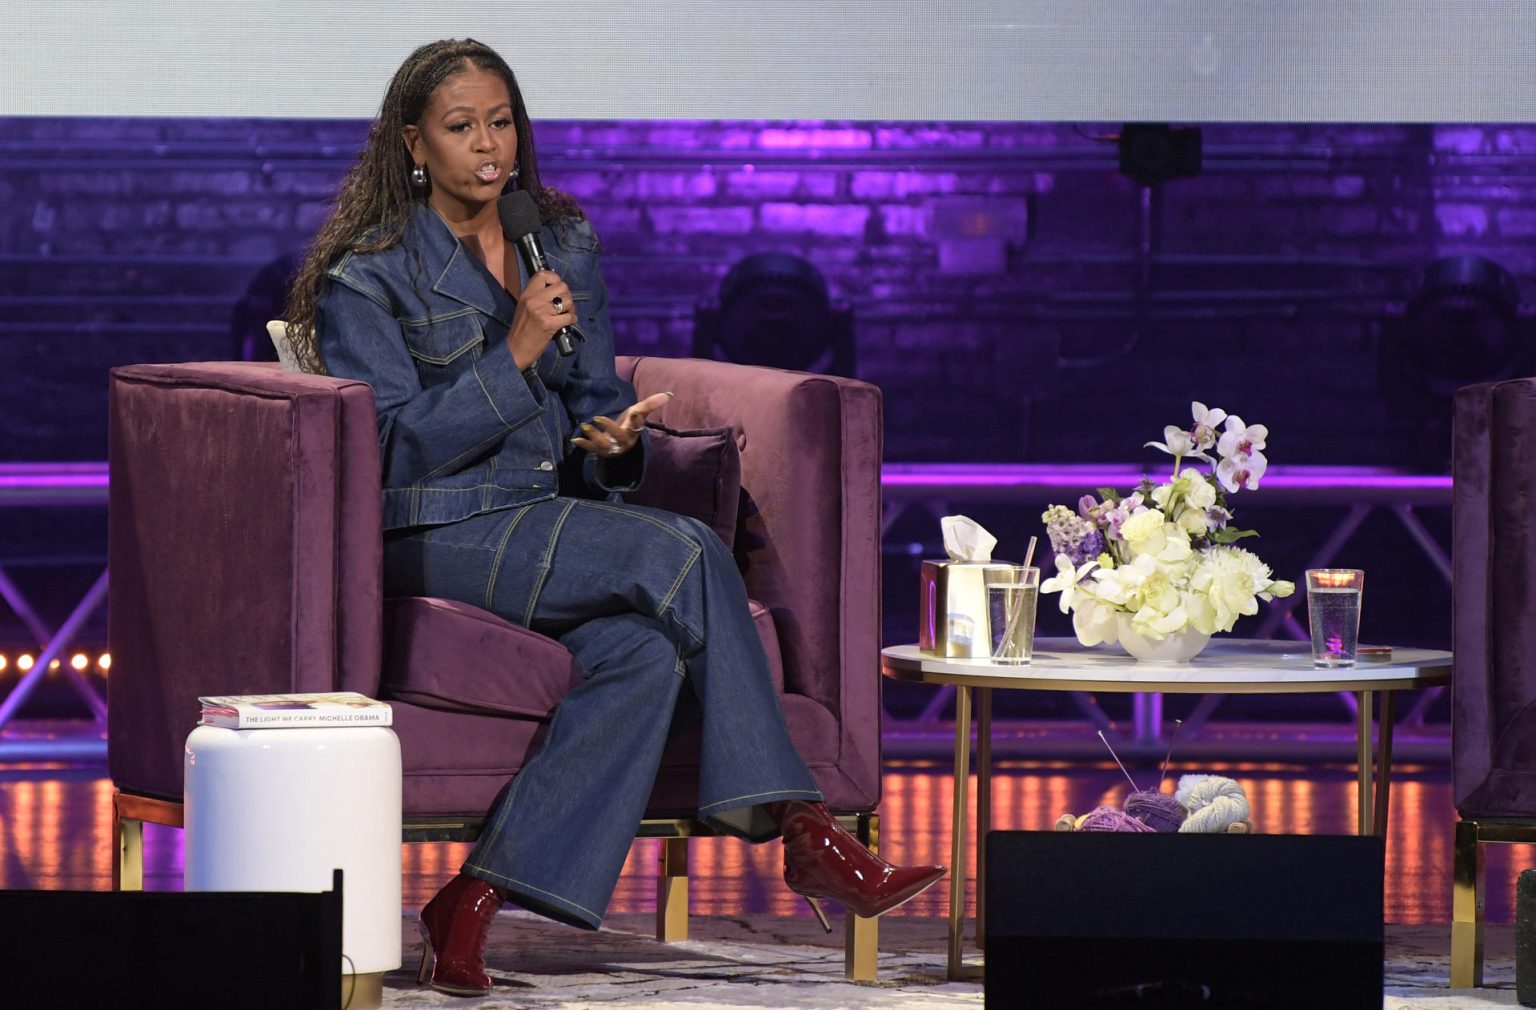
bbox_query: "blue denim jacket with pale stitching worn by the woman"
[315,204,647,530]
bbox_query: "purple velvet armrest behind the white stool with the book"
[108,362,382,797]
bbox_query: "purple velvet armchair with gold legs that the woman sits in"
[108,358,882,978]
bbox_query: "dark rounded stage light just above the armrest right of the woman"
[693,252,854,378]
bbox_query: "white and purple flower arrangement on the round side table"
[1040,402,1296,645]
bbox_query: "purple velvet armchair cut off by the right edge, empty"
[1452,378,1536,989]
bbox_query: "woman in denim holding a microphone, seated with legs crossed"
[289,40,943,995]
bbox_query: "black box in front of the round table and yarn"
[986,832,1385,1010]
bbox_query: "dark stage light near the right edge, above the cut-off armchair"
[1378,255,1536,471]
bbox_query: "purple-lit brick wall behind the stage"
[0,118,1536,699]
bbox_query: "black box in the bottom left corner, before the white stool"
[0,870,343,1010]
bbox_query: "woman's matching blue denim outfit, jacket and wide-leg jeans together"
[315,204,820,929]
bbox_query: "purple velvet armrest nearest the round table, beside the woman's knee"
[619,358,883,797]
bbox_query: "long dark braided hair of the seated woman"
[286,38,581,371]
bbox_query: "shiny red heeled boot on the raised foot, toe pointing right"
[776,800,945,933]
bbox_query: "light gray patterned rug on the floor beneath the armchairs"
[374,910,1519,1010]
